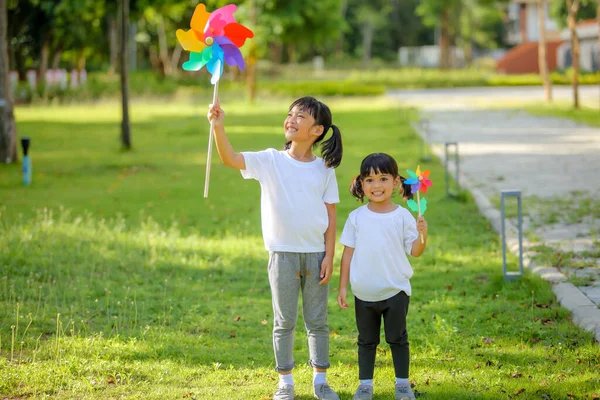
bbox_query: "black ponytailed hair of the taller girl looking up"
[283,96,343,168]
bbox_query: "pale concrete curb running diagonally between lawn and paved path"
[413,126,600,345]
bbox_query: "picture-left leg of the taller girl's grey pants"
[269,252,300,372]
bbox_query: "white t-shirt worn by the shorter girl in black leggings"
[340,205,418,301]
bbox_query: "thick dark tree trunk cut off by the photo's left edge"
[0,0,17,164]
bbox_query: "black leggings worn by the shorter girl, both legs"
[354,292,410,380]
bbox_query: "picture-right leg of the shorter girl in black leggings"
[383,292,410,379]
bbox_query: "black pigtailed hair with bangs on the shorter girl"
[349,153,412,202]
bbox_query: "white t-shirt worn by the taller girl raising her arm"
[241,149,340,253]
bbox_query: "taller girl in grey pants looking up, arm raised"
[208,97,342,400]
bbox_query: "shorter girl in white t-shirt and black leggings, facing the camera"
[338,153,427,400]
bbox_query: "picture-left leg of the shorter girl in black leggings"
[354,296,381,381]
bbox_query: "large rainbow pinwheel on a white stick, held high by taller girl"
[175,4,254,197]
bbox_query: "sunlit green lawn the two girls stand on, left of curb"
[0,98,600,400]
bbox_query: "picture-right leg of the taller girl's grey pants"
[300,253,329,372]
